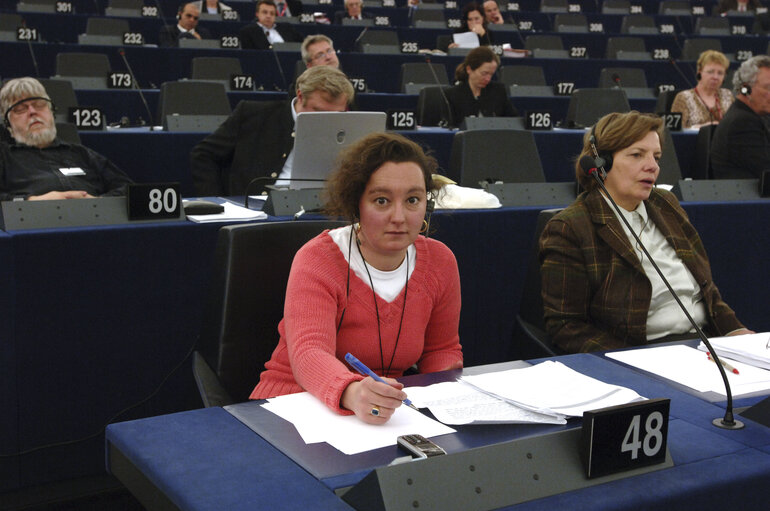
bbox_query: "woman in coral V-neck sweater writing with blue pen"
[250,133,463,424]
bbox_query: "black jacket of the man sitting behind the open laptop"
[190,101,294,196]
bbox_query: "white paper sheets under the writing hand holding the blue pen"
[262,392,455,454]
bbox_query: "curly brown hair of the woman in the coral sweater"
[324,133,438,221]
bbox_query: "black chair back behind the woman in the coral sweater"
[193,221,346,406]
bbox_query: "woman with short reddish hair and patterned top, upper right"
[671,50,733,128]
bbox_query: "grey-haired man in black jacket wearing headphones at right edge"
[711,55,770,179]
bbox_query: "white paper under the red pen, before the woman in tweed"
[607,345,770,397]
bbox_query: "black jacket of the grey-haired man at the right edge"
[711,100,770,179]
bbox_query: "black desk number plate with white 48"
[580,399,671,478]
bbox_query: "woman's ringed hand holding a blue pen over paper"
[342,353,417,424]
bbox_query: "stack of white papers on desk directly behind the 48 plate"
[404,361,644,424]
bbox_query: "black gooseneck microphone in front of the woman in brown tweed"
[580,155,744,429]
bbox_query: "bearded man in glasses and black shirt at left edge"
[0,77,131,201]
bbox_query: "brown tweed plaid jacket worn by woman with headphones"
[540,189,743,353]
